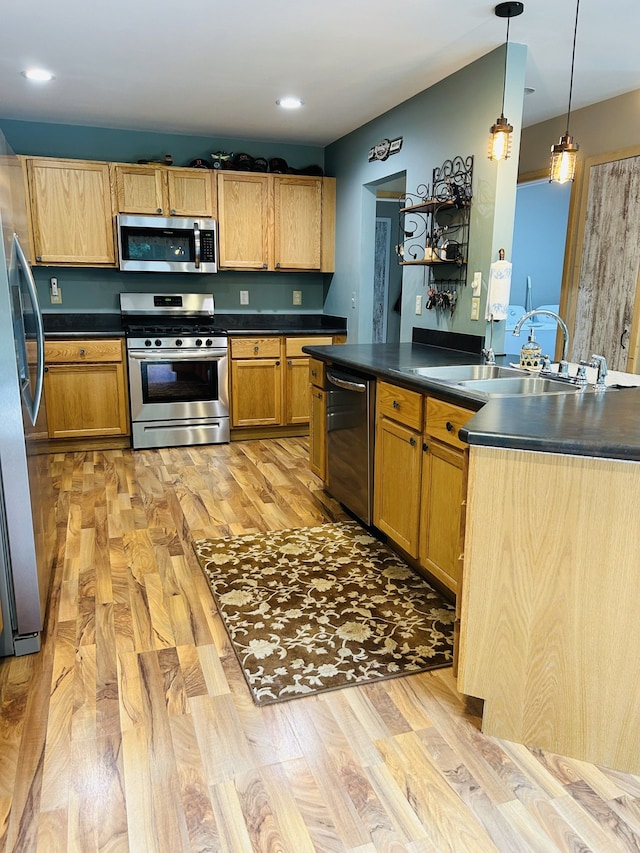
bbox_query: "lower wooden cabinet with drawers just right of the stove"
[231,335,333,427]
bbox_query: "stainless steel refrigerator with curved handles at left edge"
[0,128,55,655]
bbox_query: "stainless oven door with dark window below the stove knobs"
[129,347,229,422]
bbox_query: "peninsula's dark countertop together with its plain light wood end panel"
[306,333,640,773]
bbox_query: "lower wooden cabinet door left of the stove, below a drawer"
[45,362,129,438]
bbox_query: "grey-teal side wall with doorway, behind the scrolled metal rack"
[325,43,526,348]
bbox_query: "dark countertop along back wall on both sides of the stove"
[42,311,347,338]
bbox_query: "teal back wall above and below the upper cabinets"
[0,118,327,314]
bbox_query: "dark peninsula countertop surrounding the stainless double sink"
[304,344,640,461]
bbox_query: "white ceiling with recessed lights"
[0,0,640,146]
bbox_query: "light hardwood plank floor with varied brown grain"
[0,439,640,853]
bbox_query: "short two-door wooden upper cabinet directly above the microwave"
[111,163,216,218]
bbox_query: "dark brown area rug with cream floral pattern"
[194,522,455,705]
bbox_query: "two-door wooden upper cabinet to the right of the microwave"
[218,172,335,272]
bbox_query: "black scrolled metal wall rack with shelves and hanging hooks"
[396,154,473,313]
